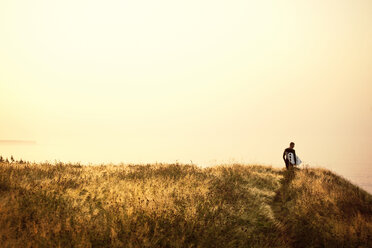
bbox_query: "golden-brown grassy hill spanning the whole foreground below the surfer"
[0,163,372,247]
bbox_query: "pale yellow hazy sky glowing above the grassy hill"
[0,0,372,174]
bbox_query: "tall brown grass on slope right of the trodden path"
[278,168,372,247]
